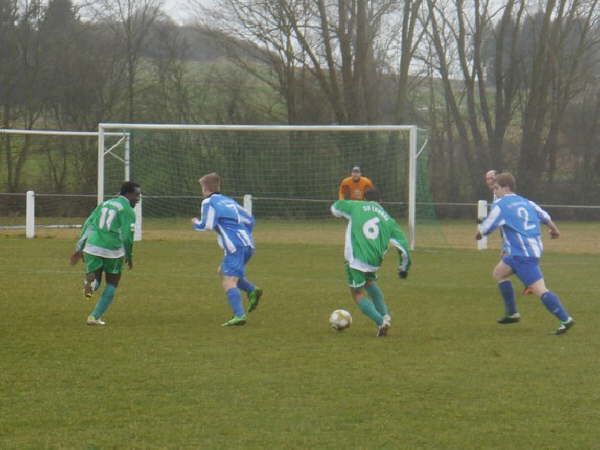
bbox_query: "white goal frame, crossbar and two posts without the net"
[98,123,426,250]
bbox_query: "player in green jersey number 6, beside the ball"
[331,189,411,337]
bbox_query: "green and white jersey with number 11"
[76,195,135,261]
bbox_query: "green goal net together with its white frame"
[98,124,436,245]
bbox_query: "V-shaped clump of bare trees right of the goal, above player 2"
[428,0,598,199]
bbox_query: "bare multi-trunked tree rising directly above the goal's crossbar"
[203,0,410,123]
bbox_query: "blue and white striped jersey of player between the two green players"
[193,192,255,253]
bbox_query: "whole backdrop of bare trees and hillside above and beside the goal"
[0,0,600,216]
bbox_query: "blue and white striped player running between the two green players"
[192,172,262,327]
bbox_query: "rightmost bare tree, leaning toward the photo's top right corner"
[518,0,599,195]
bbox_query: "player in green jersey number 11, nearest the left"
[70,181,141,325]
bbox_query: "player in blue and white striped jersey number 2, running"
[475,172,575,335]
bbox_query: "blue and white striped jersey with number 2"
[481,194,551,258]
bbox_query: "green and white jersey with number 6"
[331,200,411,272]
